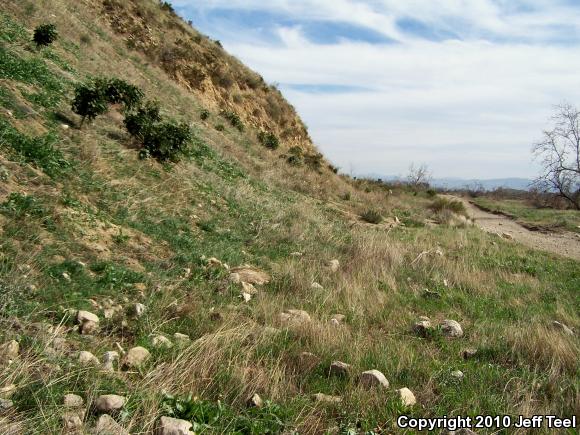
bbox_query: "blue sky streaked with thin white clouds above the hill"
[171,0,580,179]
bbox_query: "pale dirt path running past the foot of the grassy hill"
[449,196,580,260]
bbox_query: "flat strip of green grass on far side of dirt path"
[473,197,580,233]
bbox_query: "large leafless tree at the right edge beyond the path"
[532,103,580,210]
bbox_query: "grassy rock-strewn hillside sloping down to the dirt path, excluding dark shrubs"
[0,0,580,434]
